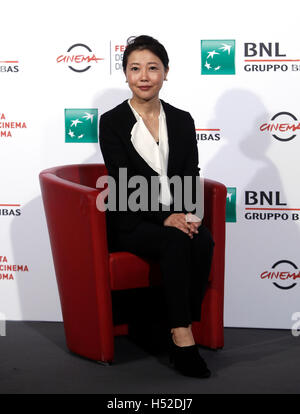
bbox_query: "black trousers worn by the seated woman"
[114,221,214,328]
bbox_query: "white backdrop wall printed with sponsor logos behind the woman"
[0,0,300,328]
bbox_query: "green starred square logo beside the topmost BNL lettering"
[201,40,235,75]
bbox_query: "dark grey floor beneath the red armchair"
[0,321,300,395]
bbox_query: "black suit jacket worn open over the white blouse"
[99,100,199,233]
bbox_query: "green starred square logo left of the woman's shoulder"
[65,108,98,143]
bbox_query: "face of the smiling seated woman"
[125,49,168,101]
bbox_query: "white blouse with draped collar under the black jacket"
[128,99,173,206]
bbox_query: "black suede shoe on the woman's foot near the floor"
[170,335,211,378]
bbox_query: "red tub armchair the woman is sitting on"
[39,164,227,362]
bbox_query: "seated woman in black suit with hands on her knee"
[100,36,214,377]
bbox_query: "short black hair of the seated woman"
[122,35,169,72]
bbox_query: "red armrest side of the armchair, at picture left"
[39,171,113,358]
